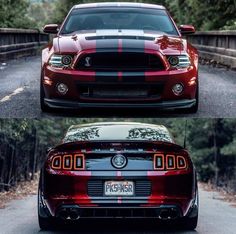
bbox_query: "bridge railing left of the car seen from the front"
[0,28,49,61]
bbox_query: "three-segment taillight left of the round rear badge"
[51,154,85,171]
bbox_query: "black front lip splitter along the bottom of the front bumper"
[44,98,196,110]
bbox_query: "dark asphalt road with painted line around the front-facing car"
[0,56,236,118]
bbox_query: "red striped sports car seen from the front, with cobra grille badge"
[41,3,198,112]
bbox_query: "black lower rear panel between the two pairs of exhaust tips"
[81,207,158,218]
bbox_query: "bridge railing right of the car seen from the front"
[188,31,236,69]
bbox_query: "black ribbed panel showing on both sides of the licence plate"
[88,180,151,197]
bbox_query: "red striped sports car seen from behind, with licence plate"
[38,123,198,229]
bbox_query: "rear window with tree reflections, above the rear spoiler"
[63,124,173,143]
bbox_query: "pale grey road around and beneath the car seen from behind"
[0,187,236,234]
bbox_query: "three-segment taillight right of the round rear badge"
[154,154,187,171]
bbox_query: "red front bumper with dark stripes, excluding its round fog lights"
[42,66,198,109]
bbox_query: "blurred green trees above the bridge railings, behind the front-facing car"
[0,0,236,30]
